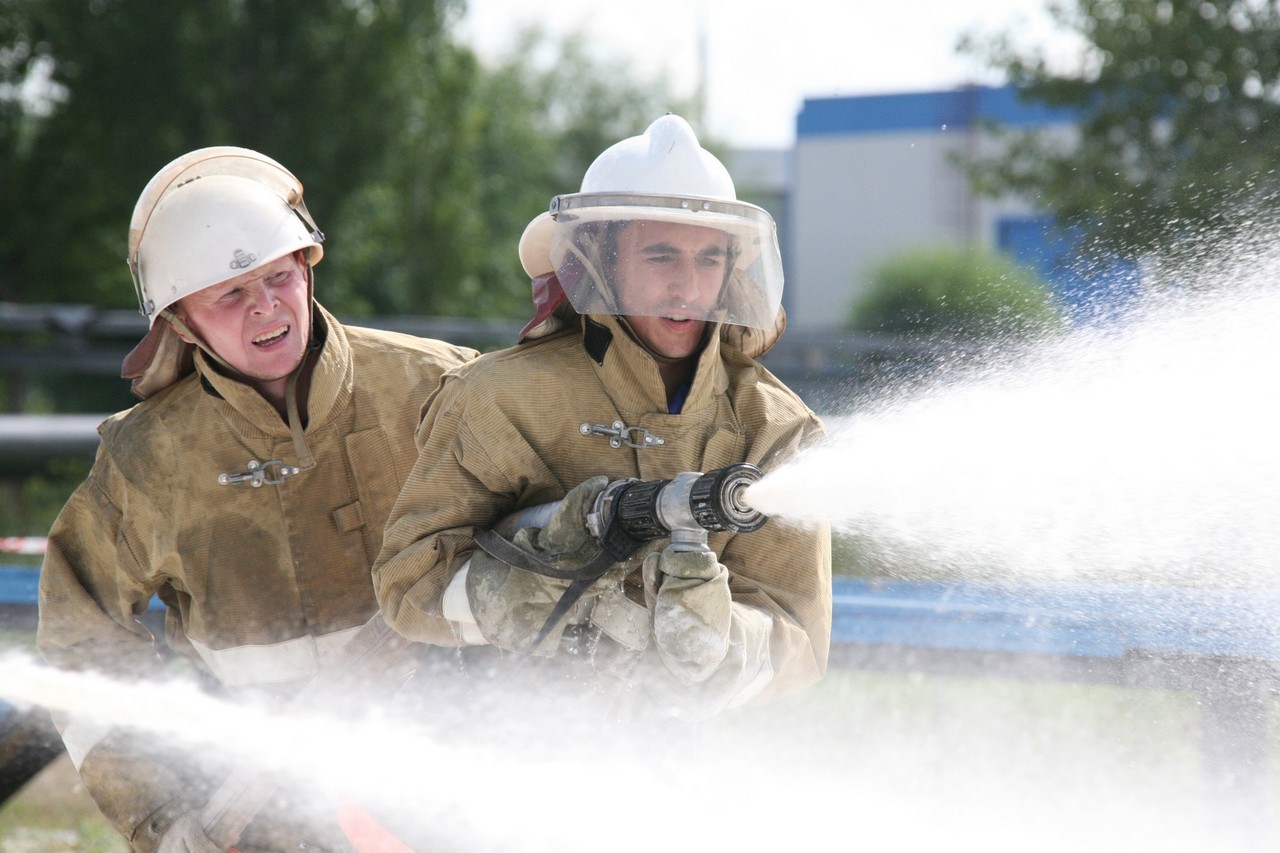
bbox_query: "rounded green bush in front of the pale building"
[849,246,1062,339]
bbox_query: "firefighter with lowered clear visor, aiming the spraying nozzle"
[374,115,831,727]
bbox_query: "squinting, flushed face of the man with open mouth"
[174,252,311,386]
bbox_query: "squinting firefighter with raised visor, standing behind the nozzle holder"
[38,147,476,852]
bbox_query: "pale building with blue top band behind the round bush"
[742,86,1132,329]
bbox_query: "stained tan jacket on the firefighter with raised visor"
[38,305,476,850]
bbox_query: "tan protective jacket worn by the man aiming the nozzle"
[374,316,831,703]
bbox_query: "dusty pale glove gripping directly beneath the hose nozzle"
[643,548,733,685]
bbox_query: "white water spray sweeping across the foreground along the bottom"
[0,656,1208,853]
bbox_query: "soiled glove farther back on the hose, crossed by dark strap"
[467,476,617,656]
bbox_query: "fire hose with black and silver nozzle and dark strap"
[201,462,768,848]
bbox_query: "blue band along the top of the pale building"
[796,86,1078,142]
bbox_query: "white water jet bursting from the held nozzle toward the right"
[745,259,1280,587]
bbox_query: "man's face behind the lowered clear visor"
[614,220,728,359]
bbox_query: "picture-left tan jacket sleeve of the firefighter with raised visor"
[37,452,215,850]
